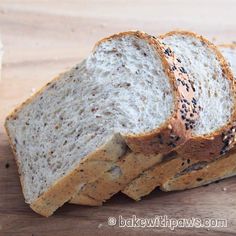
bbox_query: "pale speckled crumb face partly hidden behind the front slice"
[163,33,234,136]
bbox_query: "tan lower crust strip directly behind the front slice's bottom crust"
[70,152,163,206]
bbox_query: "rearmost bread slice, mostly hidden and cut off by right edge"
[161,45,236,191]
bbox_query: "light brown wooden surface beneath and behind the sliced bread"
[0,0,236,236]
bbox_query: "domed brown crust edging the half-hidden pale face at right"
[160,31,236,160]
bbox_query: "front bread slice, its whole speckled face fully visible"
[5,31,197,216]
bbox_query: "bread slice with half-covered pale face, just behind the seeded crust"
[123,32,235,200]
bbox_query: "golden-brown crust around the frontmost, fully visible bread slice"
[5,31,197,216]
